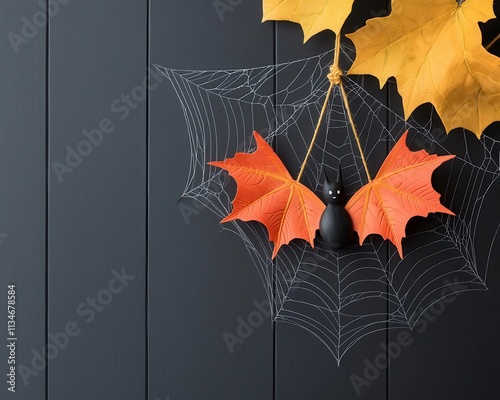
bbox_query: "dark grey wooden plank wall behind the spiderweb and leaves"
[0,0,500,400]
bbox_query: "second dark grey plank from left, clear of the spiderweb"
[48,0,147,400]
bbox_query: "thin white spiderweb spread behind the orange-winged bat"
[156,50,500,363]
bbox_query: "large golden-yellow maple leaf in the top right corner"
[346,0,500,138]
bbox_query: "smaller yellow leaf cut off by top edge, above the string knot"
[262,0,354,43]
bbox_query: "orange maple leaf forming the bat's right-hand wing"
[346,131,455,258]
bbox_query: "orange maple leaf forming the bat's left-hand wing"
[209,132,325,258]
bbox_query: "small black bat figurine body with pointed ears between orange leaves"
[319,163,353,250]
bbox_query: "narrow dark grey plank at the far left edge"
[0,0,46,400]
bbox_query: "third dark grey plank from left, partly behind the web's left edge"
[149,0,273,400]
